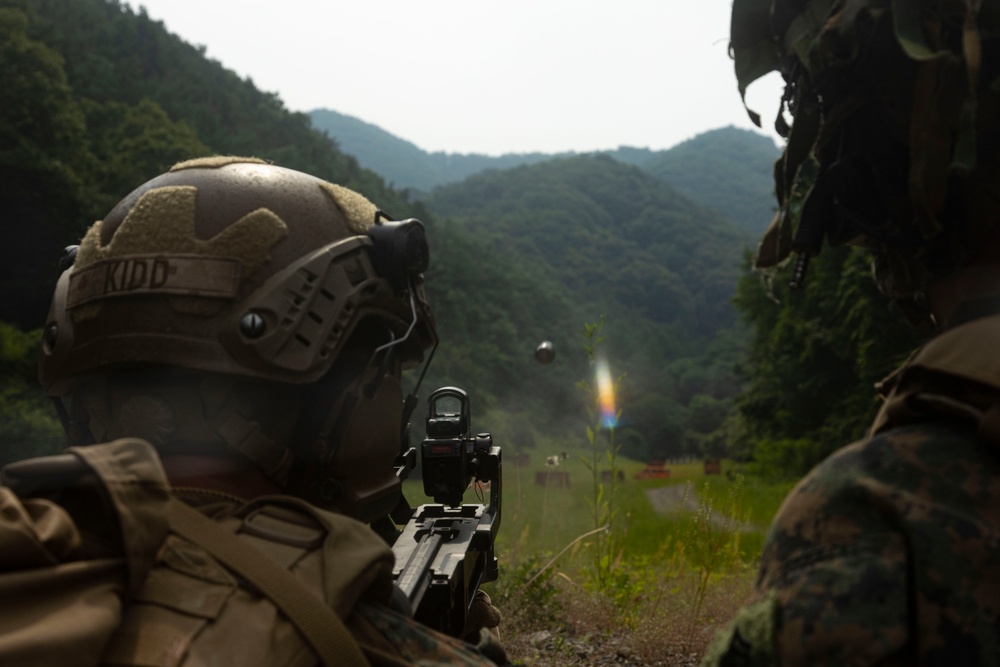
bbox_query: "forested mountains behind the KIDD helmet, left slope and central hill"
[0,0,745,458]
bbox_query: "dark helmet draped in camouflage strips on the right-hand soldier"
[730,0,1000,319]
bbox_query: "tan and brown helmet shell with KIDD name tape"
[40,158,433,394]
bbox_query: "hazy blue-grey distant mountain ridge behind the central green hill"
[308,109,780,234]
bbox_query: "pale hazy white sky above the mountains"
[127,0,780,155]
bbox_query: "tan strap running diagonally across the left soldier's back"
[167,498,369,667]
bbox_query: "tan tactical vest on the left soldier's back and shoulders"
[0,439,393,667]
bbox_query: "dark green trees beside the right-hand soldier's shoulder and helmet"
[728,247,921,477]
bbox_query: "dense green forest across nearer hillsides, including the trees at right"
[0,0,915,475]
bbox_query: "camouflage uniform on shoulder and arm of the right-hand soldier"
[704,315,1000,665]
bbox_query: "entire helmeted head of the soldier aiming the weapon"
[40,157,436,519]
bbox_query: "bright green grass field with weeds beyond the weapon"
[405,452,792,666]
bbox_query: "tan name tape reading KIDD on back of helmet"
[66,254,240,308]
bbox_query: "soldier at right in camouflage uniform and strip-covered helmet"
[705,0,1000,665]
